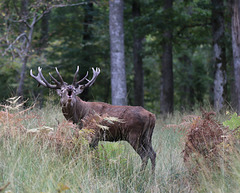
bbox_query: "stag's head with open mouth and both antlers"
[30,66,100,107]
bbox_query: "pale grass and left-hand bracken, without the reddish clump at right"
[0,98,240,192]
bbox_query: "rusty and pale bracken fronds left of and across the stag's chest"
[0,97,121,155]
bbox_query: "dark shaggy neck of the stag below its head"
[62,97,89,123]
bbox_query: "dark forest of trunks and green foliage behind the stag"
[0,0,240,113]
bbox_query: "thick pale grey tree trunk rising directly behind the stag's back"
[109,0,127,105]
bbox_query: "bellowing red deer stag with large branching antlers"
[30,67,156,172]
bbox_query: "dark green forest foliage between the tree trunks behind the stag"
[0,0,232,113]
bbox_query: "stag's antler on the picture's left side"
[30,67,64,89]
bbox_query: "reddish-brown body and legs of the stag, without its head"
[62,97,156,171]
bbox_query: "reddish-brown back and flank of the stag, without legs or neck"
[86,102,156,141]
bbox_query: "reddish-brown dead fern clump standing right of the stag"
[183,111,232,175]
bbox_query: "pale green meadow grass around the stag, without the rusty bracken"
[0,106,240,193]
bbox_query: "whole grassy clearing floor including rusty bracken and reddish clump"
[0,98,240,192]
